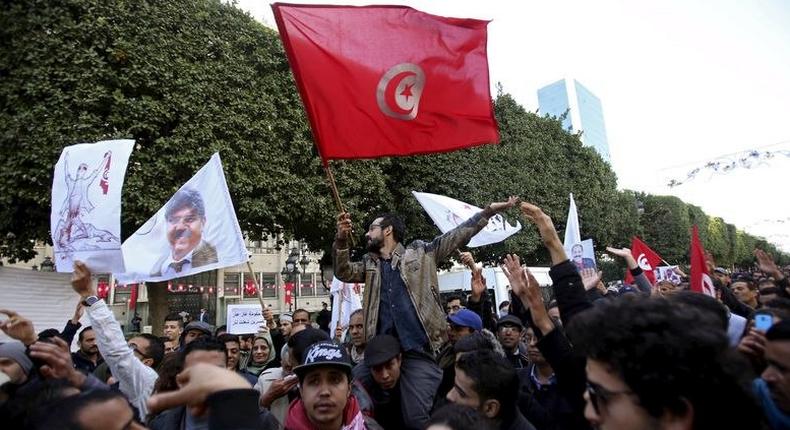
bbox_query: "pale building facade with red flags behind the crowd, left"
[2,238,333,332]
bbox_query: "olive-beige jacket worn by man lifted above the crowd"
[332,208,494,354]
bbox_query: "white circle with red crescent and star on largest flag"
[376,63,425,121]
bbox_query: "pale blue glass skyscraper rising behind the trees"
[538,79,611,163]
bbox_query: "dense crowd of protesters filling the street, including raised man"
[0,197,790,430]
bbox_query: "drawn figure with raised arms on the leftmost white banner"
[56,151,120,251]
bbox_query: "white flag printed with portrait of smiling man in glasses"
[116,154,248,283]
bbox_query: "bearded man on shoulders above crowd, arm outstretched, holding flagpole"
[332,197,518,429]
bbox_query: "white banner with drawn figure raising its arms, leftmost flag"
[50,140,134,272]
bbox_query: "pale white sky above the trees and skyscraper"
[237,0,790,252]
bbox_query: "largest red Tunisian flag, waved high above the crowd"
[272,3,499,163]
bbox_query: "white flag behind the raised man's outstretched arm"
[411,191,521,248]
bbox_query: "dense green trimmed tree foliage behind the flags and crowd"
[0,0,787,272]
